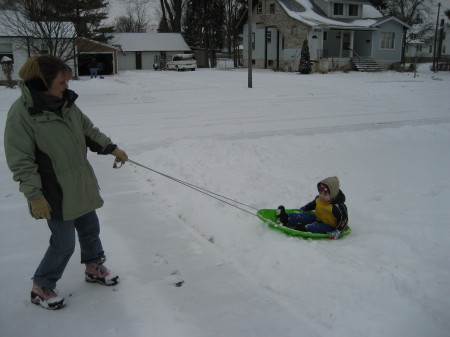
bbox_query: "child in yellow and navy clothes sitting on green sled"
[277,177,348,239]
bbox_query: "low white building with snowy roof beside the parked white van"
[110,33,192,70]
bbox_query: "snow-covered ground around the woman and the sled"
[0,65,450,337]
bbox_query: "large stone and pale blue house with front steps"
[243,0,409,70]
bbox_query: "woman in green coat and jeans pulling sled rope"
[4,55,128,309]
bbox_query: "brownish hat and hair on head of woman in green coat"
[19,55,72,89]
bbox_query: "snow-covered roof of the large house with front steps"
[278,0,410,29]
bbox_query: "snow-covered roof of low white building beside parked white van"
[109,33,191,52]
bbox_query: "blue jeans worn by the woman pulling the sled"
[33,211,105,289]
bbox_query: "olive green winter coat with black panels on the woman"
[4,83,116,220]
